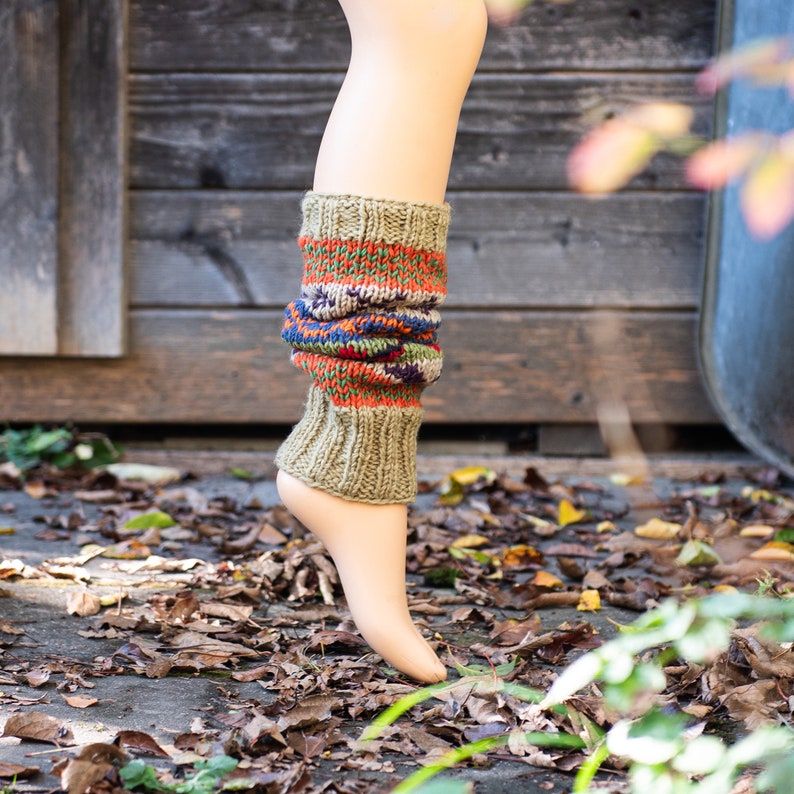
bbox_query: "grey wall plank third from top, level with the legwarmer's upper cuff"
[130,191,705,310]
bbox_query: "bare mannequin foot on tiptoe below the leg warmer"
[277,471,447,683]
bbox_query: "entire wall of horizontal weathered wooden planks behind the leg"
[0,0,716,424]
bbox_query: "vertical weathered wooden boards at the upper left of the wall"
[0,0,128,357]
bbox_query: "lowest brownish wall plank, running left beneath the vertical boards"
[0,310,715,424]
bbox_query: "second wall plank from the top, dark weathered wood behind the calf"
[130,73,711,190]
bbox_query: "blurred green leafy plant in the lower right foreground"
[362,593,794,794]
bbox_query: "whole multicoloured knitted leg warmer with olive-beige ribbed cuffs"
[276,193,449,504]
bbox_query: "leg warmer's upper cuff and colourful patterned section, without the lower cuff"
[282,193,449,408]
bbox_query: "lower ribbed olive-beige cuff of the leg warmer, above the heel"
[276,387,422,504]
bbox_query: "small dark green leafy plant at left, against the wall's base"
[0,425,121,472]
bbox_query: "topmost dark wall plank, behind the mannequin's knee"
[132,0,716,71]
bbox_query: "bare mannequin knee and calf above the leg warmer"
[314,0,486,203]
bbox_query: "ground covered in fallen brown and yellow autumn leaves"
[0,458,794,794]
